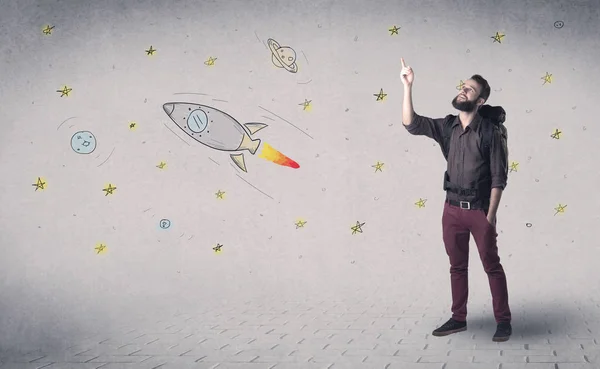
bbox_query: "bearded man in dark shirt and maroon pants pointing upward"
[400,59,512,342]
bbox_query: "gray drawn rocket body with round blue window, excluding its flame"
[163,102,267,172]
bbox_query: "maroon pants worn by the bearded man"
[442,202,511,323]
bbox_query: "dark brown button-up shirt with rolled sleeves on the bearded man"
[404,113,508,201]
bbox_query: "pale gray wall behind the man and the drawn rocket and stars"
[0,0,600,351]
